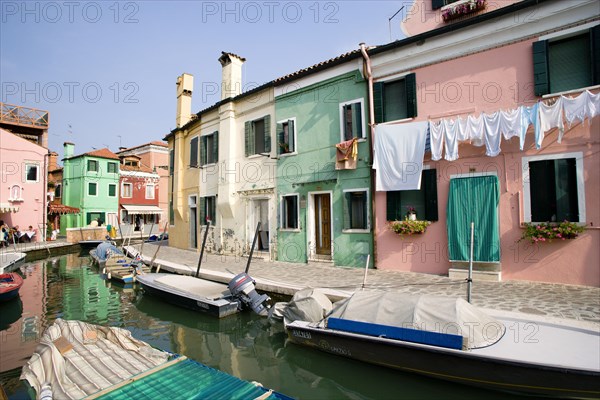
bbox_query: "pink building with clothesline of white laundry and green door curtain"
[368,0,600,286]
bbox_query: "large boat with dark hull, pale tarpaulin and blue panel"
[283,291,600,399]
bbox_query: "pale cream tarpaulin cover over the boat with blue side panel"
[329,291,506,349]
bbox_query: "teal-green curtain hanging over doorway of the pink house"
[446,176,500,262]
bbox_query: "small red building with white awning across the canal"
[119,155,163,233]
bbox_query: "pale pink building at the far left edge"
[0,128,48,242]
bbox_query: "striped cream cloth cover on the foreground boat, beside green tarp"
[21,319,170,399]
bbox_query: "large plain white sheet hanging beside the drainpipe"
[373,121,433,191]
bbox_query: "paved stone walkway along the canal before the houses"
[127,243,600,325]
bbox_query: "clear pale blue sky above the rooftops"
[0,0,409,156]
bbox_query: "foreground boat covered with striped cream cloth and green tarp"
[21,319,289,400]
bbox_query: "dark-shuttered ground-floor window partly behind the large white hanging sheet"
[386,169,438,221]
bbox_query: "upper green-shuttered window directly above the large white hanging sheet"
[373,74,417,123]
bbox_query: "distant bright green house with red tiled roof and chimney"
[60,142,120,234]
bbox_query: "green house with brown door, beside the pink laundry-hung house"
[275,69,373,267]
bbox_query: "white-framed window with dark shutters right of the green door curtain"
[523,153,585,222]
